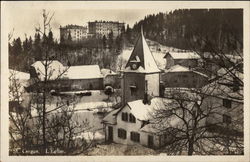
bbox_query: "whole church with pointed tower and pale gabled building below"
[102,30,176,148]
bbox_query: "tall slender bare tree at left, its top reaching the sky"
[20,10,94,154]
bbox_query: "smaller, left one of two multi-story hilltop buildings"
[60,25,88,42]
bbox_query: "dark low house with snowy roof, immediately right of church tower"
[161,65,209,88]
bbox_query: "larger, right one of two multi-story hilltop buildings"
[88,21,124,38]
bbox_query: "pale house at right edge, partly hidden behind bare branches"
[202,68,244,137]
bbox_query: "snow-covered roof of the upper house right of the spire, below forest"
[164,52,200,59]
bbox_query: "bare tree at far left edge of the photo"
[9,70,30,154]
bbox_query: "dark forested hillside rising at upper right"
[126,9,243,52]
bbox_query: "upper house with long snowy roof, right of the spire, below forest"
[164,52,200,69]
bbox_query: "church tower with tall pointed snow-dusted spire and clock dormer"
[121,29,161,105]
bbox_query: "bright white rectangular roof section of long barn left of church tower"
[66,65,103,79]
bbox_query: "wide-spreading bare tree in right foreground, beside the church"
[152,85,243,155]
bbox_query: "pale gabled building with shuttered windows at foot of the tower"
[103,97,179,148]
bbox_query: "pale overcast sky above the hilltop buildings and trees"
[5,1,178,40]
